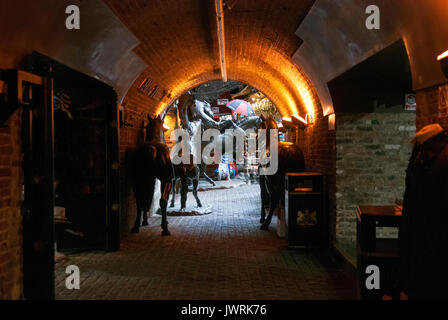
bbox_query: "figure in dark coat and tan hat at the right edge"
[399,124,448,300]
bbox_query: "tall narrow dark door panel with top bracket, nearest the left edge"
[0,70,54,299]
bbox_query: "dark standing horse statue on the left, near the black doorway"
[131,116,174,236]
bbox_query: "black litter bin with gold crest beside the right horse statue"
[285,172,328,248]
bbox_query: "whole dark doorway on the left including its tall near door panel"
[22,52,120,299]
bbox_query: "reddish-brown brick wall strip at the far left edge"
[0,111,22,300]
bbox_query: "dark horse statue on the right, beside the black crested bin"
[259,116,306,230]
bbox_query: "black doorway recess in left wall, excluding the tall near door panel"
[30,53,120,251]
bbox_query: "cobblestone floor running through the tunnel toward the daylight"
[55,185,355,300]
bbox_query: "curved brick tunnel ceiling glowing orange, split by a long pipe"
[105,0,319,116]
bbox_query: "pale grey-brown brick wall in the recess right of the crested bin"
[336,113,416,252]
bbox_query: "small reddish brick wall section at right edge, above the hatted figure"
[417,83,448,130]
